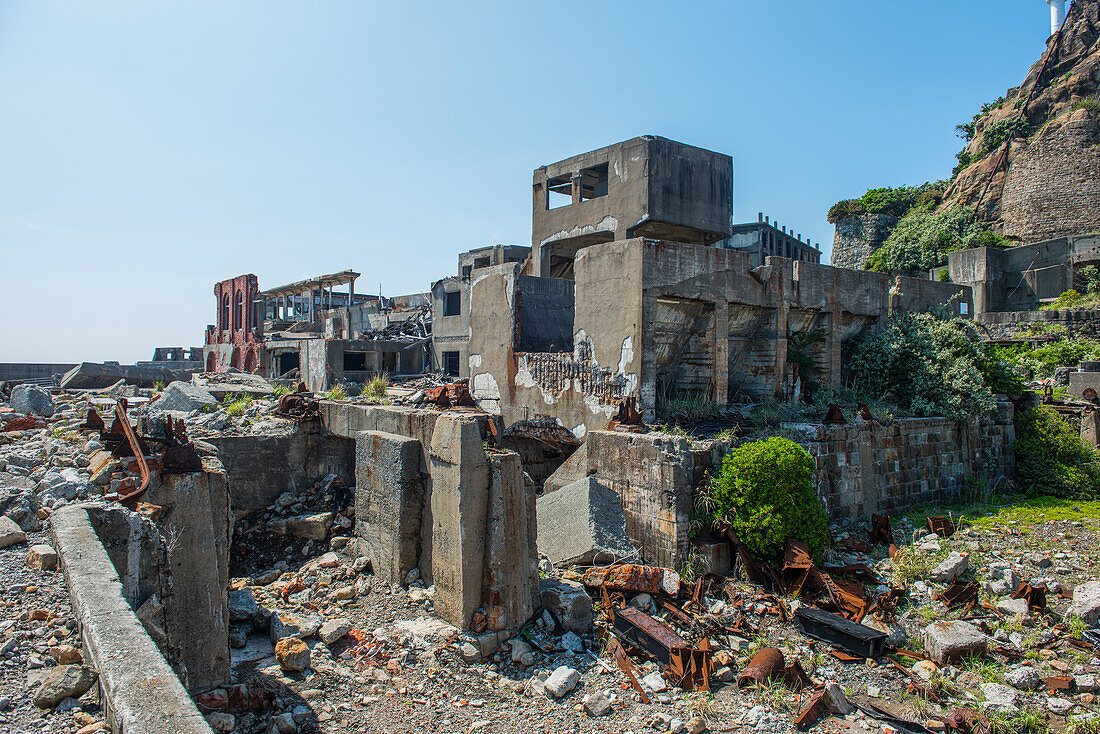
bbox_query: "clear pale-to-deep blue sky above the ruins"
[0,0,1049,362]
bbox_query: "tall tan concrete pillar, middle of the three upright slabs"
[431,415,490,628]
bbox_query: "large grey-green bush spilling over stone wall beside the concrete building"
[848,311,1023,420]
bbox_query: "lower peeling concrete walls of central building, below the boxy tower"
[470,239,971,437]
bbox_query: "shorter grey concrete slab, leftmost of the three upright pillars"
[355,430,426,583]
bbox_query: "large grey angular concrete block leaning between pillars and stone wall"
[537,476,635,565]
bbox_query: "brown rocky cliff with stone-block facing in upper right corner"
[941,0,1100,242]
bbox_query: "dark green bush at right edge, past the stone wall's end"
[1015,407,1100,500]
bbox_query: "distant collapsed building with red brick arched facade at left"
[204,270,431,391]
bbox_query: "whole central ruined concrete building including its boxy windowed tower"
[459,136,970,436]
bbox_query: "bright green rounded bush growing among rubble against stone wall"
[699,437,828,558]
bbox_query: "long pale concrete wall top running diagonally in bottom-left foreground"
[50,505,212,734]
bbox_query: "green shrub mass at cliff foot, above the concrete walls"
[865,207,1010,274]
